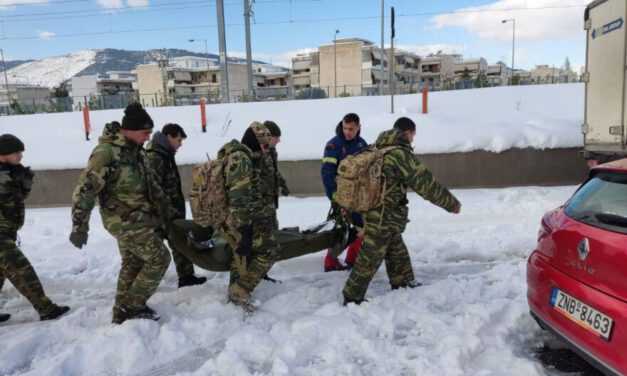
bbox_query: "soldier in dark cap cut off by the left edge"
[0,134,70,322]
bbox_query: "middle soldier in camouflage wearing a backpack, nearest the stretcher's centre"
[218,122,279,310]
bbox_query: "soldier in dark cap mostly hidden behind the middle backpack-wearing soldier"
[261,120,290,230]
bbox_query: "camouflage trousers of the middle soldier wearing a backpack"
[230,217,279,293]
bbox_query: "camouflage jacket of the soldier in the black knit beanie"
[72,122,175,237]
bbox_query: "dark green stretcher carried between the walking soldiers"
[168,219,350,272]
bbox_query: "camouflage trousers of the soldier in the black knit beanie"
[115,229,170,309]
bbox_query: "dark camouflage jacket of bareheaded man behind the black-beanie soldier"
[146,132,185,218]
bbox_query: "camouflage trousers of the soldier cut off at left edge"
[0,239,55,315]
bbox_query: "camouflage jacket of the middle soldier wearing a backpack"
[218,140,263,229]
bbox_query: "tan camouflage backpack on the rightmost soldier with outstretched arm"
[335,146,398,213]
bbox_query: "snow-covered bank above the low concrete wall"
[0,84,584,169]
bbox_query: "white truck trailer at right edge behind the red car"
[582,0,627,164]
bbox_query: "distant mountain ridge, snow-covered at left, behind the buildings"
[6,48,266,87]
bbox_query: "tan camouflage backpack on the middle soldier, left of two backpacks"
[189,159,228,229]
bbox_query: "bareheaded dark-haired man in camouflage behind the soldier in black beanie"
[146,124,207,288]
